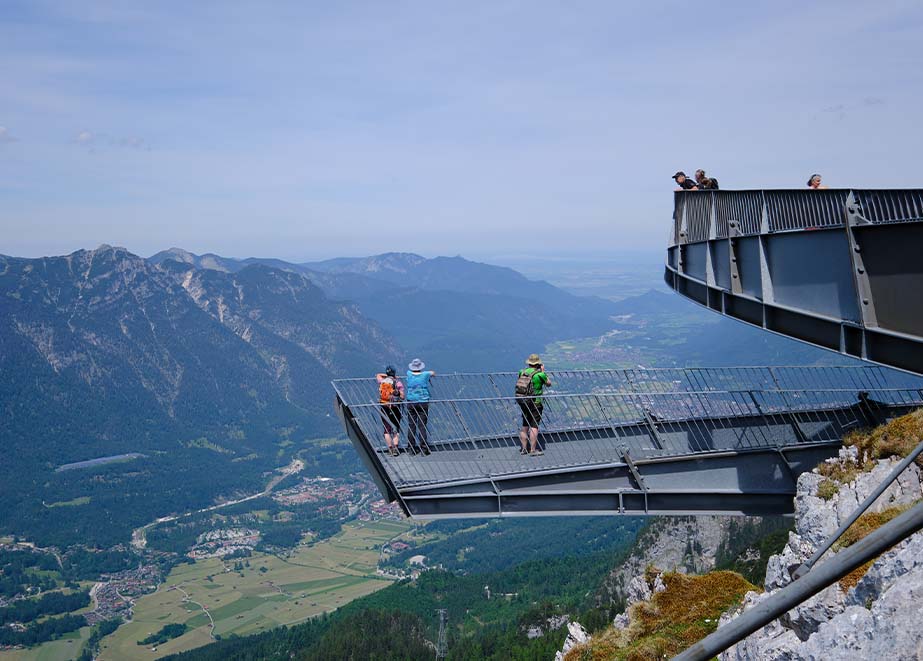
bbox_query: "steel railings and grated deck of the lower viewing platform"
[334,367,923,489]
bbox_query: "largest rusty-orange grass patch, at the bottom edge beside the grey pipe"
[565,571,757,661]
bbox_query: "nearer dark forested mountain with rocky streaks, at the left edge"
[0,246,398,544]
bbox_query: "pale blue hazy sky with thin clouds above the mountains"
[0,0,923,261]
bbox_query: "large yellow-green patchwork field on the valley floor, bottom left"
[96,521,411,661]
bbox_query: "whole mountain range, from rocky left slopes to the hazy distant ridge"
[0,246,613,546]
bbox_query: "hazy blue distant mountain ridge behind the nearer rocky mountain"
[150,248,618,372]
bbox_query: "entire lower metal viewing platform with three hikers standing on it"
[333,366,923,519]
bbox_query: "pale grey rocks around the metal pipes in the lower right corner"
[720,447,923,661]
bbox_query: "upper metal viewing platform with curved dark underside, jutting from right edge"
[665,189,923,374]
